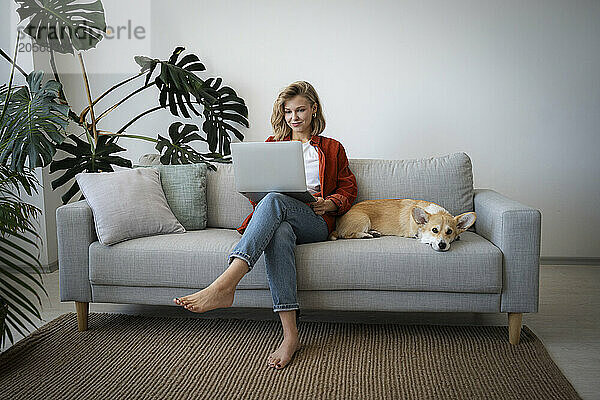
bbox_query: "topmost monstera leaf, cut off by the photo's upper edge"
[15,0,106,54]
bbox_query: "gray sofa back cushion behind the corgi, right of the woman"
[349,153,473,215]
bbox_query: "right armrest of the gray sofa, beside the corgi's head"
[474,189,542,313]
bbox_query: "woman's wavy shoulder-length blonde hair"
[271,81,325,140]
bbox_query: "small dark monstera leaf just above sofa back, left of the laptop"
[156,122,231,170]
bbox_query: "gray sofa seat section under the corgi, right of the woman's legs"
[296,232,502,293]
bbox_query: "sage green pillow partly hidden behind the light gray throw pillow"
[134,164,207,231]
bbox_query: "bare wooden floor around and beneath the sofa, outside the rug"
[3,265,600,399]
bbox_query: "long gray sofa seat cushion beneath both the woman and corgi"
[90,228,502,293]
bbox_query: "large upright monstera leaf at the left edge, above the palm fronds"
[0,71,69,172]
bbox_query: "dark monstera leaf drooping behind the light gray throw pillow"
[50,135,132,204]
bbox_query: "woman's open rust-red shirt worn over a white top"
[237,135,358,233]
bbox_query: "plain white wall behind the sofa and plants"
[25,0,600,257]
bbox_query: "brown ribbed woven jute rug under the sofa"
[0,313,579,400]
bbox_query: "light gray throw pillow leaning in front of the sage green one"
[75,168,185,246]
